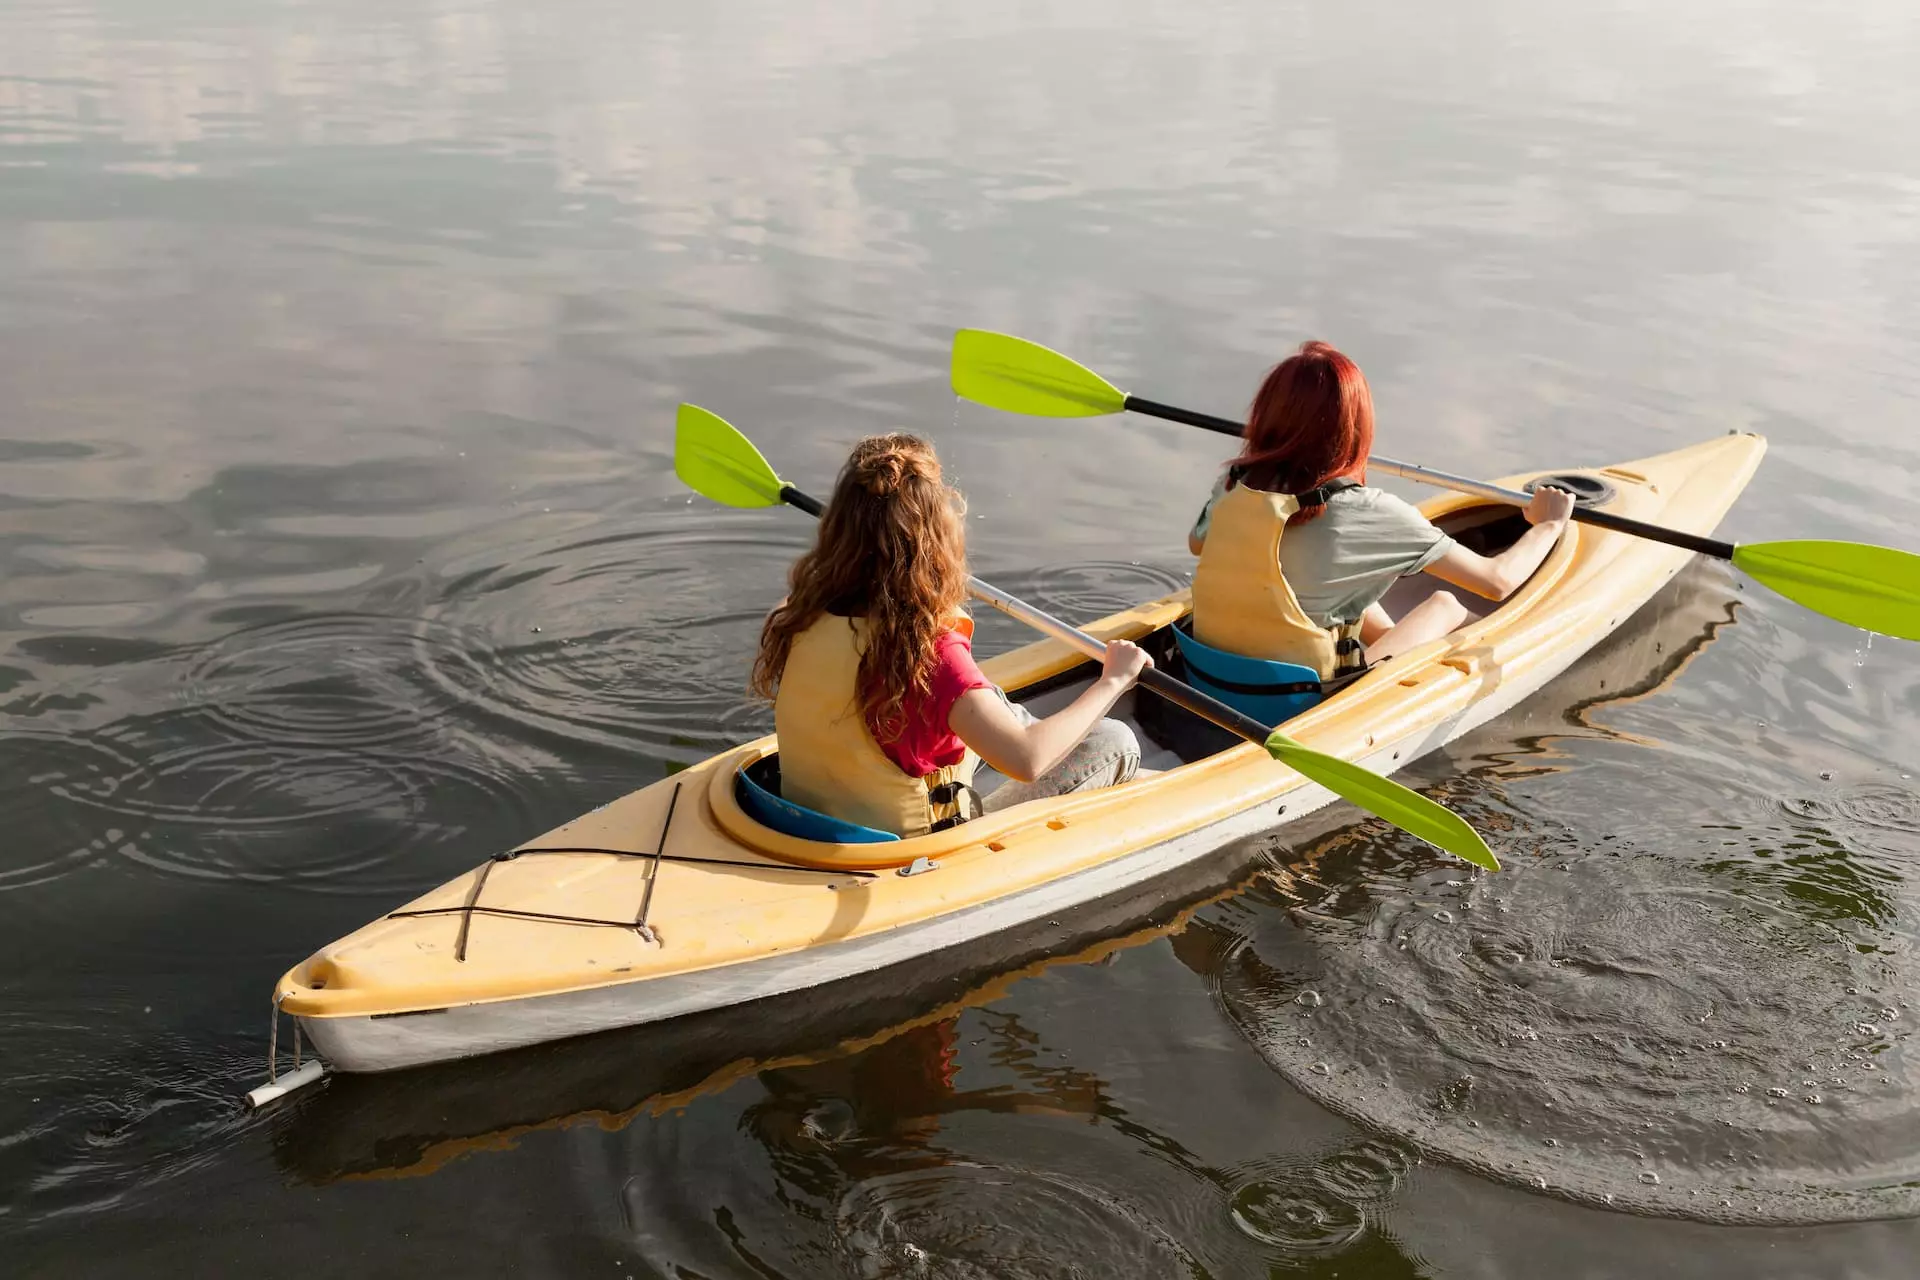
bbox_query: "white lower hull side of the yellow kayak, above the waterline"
[300,614,1597,1073]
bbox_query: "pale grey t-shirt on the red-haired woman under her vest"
[1192,476,1453,628]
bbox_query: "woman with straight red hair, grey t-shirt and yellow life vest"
[1187,342,1572,679]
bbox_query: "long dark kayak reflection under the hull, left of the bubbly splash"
[275,844,1259,1182]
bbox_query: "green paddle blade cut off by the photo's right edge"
[1734,541,1920,639]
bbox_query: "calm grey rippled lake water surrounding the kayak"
[0,0,1920,1280]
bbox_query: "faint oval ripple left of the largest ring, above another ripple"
[184,614,487,747]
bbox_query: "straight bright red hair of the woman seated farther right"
[1231,342,1373,524]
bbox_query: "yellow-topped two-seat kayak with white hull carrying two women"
[275,434,1766,1073]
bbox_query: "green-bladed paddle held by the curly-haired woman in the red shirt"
[674,405,1500,871]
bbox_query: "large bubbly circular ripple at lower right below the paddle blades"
[1215,850,1920,1222]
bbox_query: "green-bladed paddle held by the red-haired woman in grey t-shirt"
[952,328,1920,639]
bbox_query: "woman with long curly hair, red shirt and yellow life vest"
[753,434,1150,837]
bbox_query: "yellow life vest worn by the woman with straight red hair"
[1194,482,1367,679]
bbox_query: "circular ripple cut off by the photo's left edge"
[0,731,138,892]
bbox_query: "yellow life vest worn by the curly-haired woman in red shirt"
[774,614,979,837]
